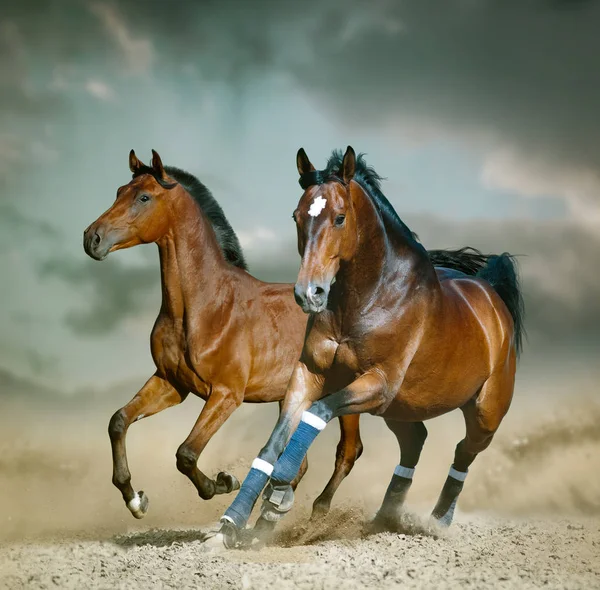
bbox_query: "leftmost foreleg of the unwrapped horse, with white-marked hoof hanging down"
[108,375,186,518]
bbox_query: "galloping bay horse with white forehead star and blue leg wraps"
[218,146,523,547]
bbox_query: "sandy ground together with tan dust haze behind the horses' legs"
[0,376,600,590]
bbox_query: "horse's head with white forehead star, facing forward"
[293,146,357,313]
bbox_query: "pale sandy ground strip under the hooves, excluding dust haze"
[0,511,600,590]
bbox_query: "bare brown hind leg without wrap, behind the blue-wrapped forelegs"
[311,414,363,519]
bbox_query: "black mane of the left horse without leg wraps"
[135,166,248,270]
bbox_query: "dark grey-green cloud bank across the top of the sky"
[0,0,600,178]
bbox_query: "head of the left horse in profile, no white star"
[83,150,177,260]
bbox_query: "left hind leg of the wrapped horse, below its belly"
[374,419,427,528]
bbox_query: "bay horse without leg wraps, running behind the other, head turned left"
[84,150,362,518]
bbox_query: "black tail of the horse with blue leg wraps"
[428,247,526,355]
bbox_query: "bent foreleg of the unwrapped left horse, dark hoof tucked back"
[176,387,243,500]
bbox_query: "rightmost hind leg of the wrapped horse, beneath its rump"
[432,368,514,526]
